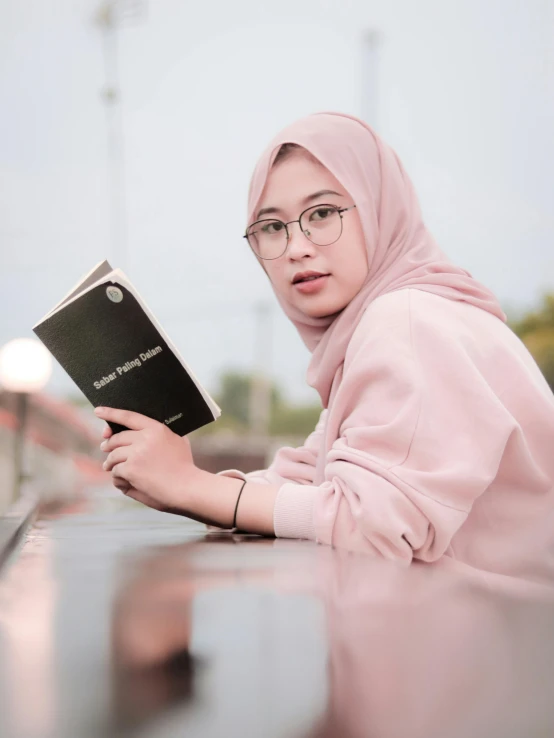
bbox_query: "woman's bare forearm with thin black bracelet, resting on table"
[187,469,279,536]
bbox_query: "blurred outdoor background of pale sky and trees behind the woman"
[0,0,554,512]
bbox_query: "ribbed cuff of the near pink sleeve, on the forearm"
[273,482,318,541]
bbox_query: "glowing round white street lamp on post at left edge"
[0,338,52,500]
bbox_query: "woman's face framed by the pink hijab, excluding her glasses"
[252,151,368,318]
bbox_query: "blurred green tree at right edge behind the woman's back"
[510,294,554,392]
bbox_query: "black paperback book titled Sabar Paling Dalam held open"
[33,261,220,436]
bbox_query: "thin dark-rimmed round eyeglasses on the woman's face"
[243,204,356,261]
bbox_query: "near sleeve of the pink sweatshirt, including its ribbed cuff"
[274,290,513,561]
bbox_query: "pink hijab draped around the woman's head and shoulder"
[248,113,506,407]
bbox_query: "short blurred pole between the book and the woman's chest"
[249,302,273,438]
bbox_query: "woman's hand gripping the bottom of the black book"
[95,408,200,515]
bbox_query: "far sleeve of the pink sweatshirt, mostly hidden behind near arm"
[219,410,327,485]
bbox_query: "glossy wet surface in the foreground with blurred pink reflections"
[0,491,554,738]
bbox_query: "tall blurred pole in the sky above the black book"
[95,0,146,269]
